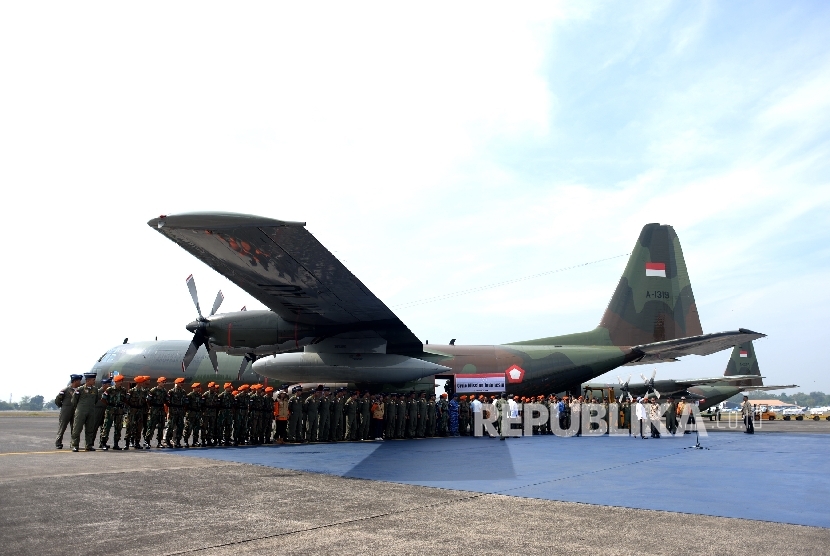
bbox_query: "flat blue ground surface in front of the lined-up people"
[171,433,830,527]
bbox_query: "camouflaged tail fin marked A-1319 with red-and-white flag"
[599,224,703,346]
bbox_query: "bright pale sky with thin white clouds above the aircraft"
[0,2,830,400]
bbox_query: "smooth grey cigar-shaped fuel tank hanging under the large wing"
[253,352,451,383]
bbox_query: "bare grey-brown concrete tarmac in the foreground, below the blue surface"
[0,415,830,555]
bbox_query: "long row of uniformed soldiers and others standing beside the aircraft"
[55,373,700,451]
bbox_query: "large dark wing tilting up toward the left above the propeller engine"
[147,212,423,355]
